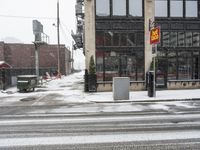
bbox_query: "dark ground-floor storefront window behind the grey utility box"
[96,50,144,81]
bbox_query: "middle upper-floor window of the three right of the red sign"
[170,0,183,17]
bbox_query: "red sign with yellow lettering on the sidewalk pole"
[150,27,160,44]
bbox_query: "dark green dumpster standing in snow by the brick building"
[17,75,37,92]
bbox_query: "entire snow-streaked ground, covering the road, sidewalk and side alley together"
[0,72,200,150]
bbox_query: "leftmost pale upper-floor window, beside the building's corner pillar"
[96,0,110,16]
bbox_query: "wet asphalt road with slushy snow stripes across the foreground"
[0,101,200,150]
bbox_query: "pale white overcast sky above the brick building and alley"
[0,0,83,68]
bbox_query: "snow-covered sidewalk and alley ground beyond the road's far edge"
[0,72,200,106]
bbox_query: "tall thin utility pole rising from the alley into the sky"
[57,0,60,77]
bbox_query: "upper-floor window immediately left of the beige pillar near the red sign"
[129,0,142,16]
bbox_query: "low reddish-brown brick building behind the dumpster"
[0,42,71,85]
